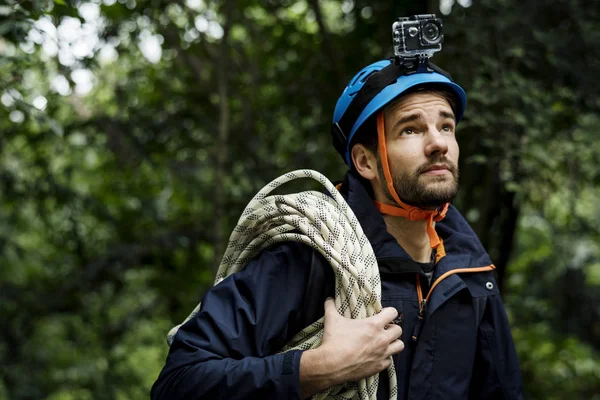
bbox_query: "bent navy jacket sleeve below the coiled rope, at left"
[151,243,312,400]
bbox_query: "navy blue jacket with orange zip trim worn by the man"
[151,174,523,400]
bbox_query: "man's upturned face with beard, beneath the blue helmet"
[378,92,459,209]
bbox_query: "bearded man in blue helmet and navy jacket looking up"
[152,54,522,400]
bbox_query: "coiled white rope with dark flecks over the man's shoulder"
[167,170,398,400]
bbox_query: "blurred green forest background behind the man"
[0,0,600,400]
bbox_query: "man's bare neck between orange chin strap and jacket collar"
[383,215,431,263]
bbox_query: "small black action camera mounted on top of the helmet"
[392,14,444,59]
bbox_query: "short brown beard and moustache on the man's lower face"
[377,157,458,209]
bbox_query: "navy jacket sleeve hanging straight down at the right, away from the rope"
[469,294,523,400]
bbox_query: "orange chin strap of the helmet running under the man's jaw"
[375,111,450,252]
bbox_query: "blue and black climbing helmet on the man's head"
[331,59,467,168]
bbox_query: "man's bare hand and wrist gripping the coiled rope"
[300,298,404,399]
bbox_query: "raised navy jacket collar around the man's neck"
[341,171,491,275]
